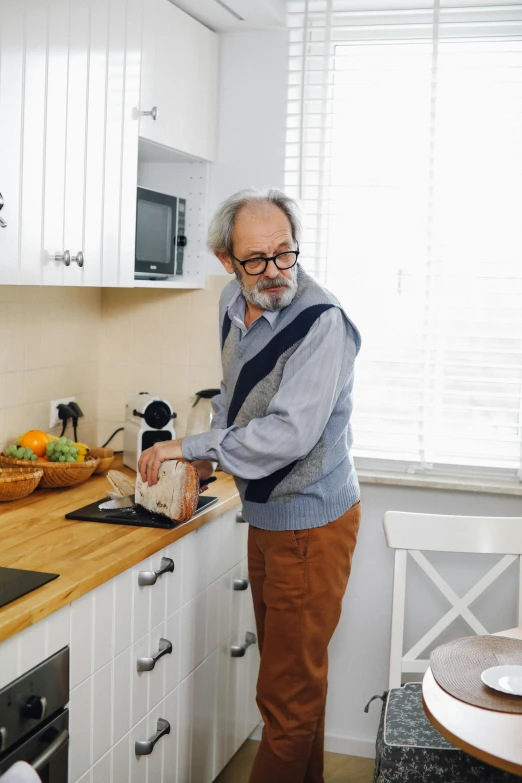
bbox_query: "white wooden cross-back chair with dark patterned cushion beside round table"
[368,511,522,783]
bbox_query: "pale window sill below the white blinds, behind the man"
[357,468,522,495]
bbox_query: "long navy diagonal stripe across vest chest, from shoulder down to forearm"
[227,304,335,427]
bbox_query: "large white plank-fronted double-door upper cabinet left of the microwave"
[0,0,142,286]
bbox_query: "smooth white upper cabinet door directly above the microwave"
[140,0,219,161]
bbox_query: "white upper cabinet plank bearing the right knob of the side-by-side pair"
[63,0,90,285]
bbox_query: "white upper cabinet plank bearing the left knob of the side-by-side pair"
[42,0,69,285]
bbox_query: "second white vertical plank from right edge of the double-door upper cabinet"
[102,0,127,286]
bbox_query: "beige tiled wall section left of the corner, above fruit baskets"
[0,286,101,446]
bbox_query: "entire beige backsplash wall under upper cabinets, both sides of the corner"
[0,275,229,456]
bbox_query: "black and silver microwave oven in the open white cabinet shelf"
[134,188,187,280]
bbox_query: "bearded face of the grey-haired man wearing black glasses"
[218,204,297,311]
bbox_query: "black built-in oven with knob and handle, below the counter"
[0,647,69,783]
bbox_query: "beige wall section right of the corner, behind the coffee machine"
[98,275,229,449]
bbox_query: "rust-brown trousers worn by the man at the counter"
[248,501,361,783]
